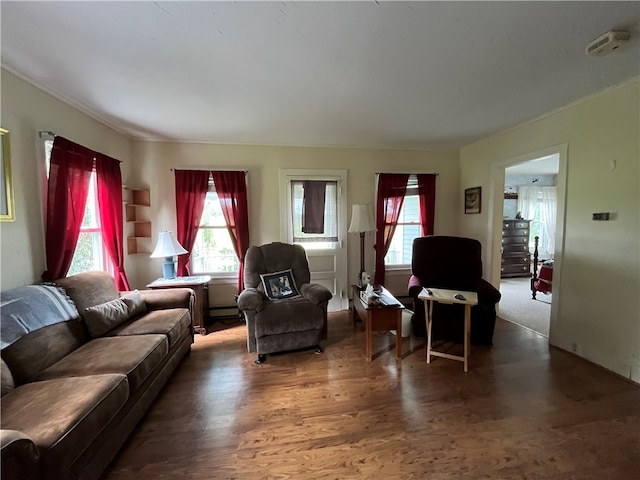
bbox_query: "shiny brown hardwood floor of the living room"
[103,311,640,480]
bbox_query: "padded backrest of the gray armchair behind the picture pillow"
[244,242,311,290]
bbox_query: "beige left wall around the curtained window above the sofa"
[0,70,131,289]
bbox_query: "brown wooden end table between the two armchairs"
[351,285,404,362]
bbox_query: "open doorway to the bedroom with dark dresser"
[499,153,560,337]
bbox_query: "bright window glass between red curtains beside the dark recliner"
[384,175,422,267]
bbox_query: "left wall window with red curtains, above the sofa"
[42,136,129,284]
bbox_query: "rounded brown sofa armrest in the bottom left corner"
[0,428,40,479]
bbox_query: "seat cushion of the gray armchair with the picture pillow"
[255,298,324,338]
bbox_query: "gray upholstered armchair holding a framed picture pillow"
[238,242,331,364]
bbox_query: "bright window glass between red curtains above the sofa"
[44,140,113,276]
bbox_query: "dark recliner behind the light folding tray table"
[409,235,501,345]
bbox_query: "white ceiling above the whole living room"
[0,0,640,148]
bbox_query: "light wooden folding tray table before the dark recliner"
[418,288,478,372]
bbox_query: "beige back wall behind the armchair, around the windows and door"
[128,142,460,305]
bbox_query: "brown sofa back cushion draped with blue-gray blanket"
[0,285,88,393]
